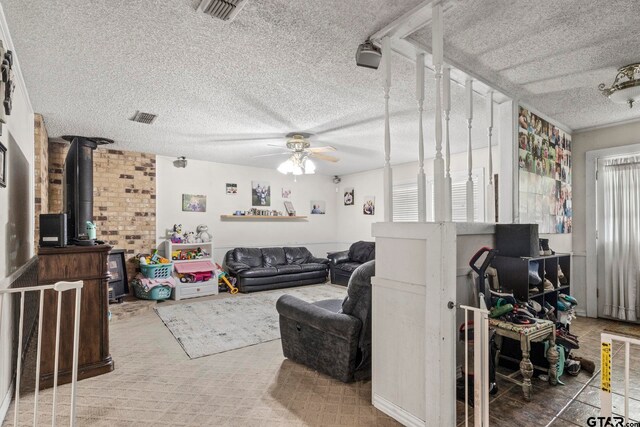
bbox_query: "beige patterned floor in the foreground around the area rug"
[4,286,398,427]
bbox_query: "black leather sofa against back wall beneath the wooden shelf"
[224,247,329,292]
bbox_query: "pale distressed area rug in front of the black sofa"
[155,284,347,359]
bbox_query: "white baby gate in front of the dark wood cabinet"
[0,281,83,426]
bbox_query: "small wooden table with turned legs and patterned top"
[489,319,559,400]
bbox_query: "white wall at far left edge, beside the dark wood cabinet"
[0,5,34,423]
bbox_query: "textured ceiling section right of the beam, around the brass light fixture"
[411,0,640,130]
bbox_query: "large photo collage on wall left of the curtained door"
[518,106,573,233]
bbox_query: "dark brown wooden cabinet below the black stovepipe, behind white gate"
[38,245,113,387]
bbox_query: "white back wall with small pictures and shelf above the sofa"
[156,156,341,263]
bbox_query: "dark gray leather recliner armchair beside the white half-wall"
[276,261,375,382]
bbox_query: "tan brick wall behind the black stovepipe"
[49,142,156,280]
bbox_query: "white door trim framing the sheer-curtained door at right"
[588,144,640,317]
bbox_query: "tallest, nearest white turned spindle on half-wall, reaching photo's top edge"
[432,2,445,221]
